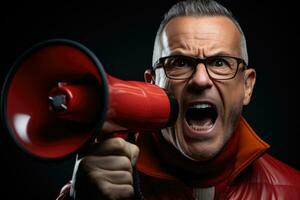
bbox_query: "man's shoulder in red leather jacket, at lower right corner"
[229,154,300,199]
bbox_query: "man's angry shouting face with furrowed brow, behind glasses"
[150,17,255,160]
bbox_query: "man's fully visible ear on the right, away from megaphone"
[243,68,256,105]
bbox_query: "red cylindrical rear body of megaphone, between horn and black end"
[107,76,171,131]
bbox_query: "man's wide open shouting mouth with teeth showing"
[185,103,218,131]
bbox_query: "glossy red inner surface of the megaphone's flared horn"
[6,45,101,158]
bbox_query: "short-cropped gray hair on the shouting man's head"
[152,0,248,65]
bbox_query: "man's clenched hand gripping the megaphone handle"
[71,138,139,200]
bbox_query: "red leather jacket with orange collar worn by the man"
[58,118,300,200]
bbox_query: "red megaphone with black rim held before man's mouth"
[1,39,178,160]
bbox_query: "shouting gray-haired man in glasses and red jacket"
[58,0,300,199]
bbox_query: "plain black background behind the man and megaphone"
[0,0,300,200]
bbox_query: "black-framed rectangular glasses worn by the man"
[153,55,247,80]
